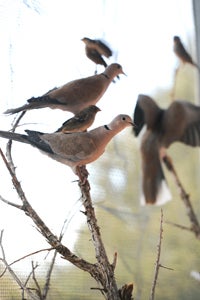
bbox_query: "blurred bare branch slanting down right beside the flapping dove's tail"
[163,155,200,239]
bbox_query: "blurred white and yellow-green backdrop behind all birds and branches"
[0,0,200,300]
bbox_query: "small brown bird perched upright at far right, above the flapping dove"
[173,36,199,69]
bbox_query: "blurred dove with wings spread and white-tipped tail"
[134,95,200,204]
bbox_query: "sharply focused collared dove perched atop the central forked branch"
[0,115,133,180]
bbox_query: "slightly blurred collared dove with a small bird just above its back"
[5,63,125,114]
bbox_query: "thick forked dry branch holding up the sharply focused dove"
[0,145,133,300]
